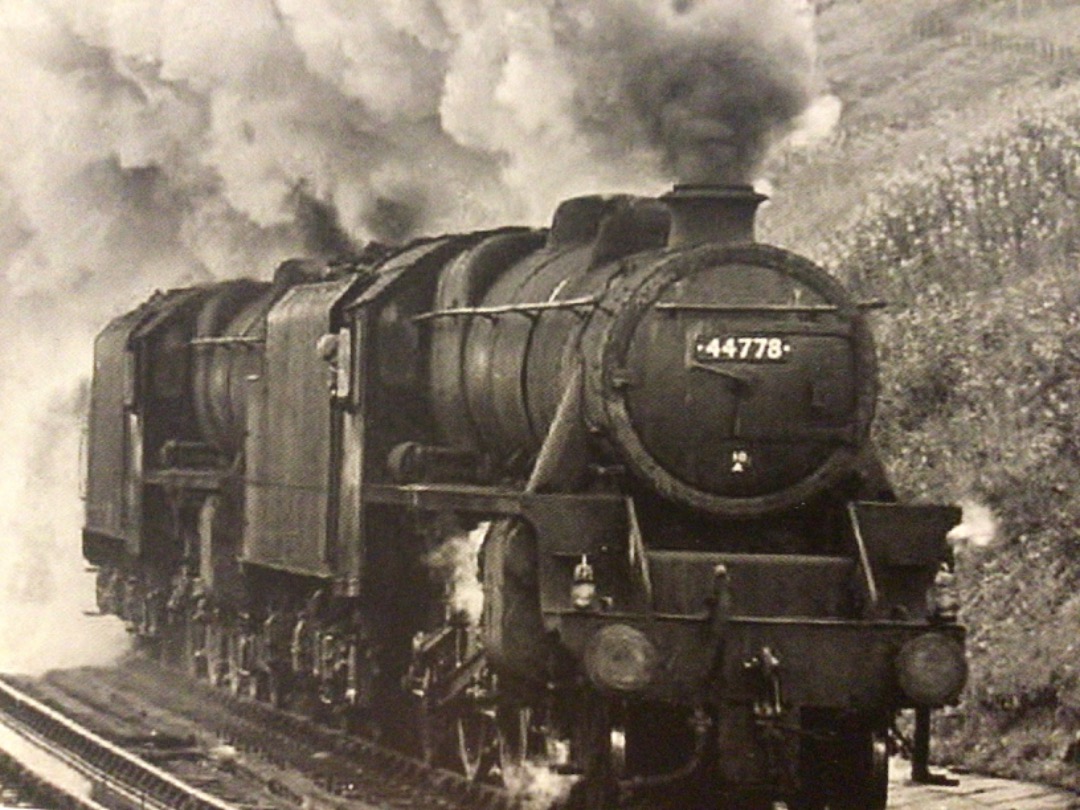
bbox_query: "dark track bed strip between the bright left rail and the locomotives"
[1,658,522,810]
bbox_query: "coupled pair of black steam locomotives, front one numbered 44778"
[83,186,967,810]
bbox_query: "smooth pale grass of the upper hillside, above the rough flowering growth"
[761,0,1080,249]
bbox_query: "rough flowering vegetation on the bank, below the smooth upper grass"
[819,106,1080,786]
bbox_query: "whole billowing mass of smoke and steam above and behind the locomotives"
[0,0,816,665]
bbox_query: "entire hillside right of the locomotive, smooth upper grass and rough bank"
[762,0,1080,787]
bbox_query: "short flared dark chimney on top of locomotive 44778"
[660,185,768,247]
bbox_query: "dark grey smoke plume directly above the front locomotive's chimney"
[552,1,815,183]
